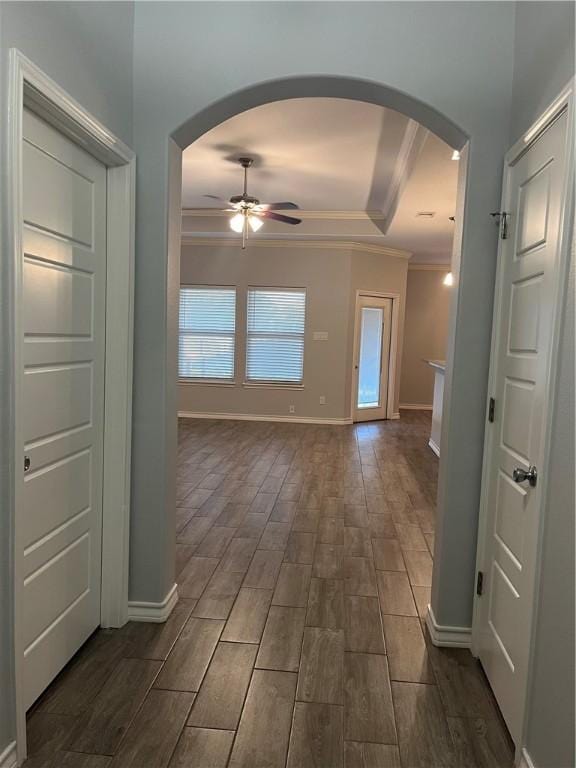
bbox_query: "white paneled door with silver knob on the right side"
[475,106,568,744]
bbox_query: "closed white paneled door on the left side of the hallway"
[16,106,106,708]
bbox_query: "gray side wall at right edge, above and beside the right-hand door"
[510,2,576,768]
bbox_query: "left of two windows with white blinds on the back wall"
[178,287,236,380]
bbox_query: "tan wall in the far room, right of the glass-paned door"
[400,267,453,405]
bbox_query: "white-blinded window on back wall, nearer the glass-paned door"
[246,288,306,384]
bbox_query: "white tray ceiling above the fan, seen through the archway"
[182,98,458,263]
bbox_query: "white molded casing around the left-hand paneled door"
[6,48,136,762]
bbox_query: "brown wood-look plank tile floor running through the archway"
[26,411,512,768]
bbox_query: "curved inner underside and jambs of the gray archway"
[161,76,472,645]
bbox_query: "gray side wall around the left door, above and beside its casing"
[0,2,133,753]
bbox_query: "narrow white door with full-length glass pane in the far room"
[353,296,392,421]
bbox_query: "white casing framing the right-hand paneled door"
[472,79,576,760]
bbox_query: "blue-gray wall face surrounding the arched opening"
[131,2,514,626]
